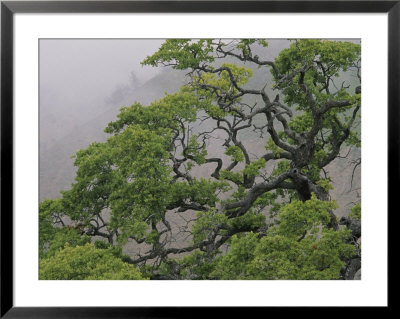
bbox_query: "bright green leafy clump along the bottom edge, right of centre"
[210,229,354,280]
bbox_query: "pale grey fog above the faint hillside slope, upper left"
[39,39,162,148]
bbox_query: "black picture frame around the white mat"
[0,0,394,318]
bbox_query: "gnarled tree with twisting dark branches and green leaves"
[39,39,361,279]
